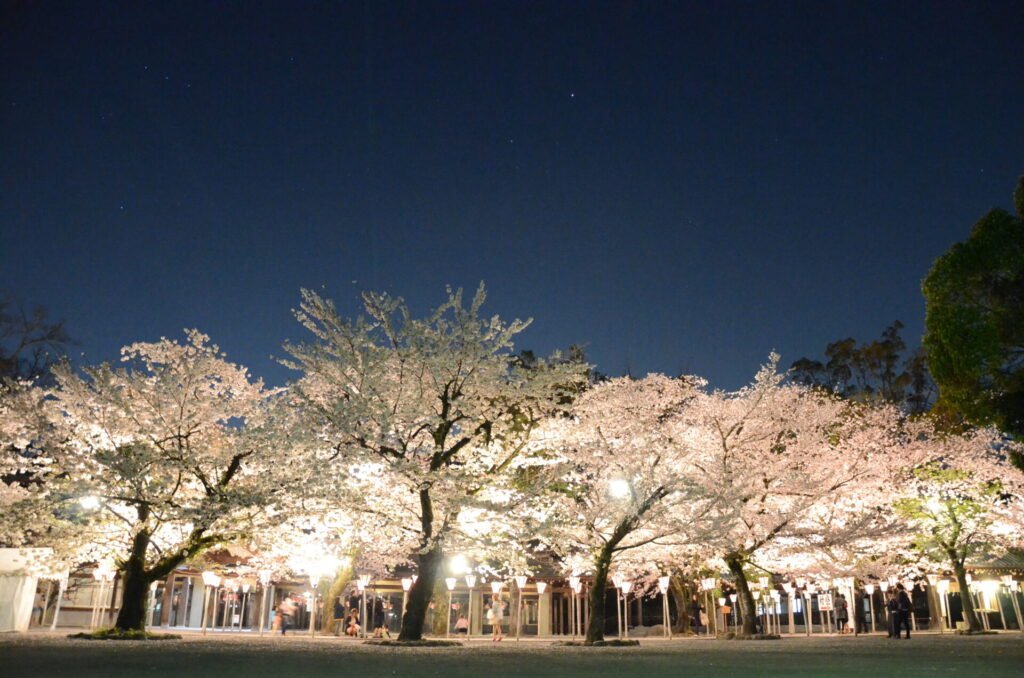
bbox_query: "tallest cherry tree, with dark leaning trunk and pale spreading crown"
[286,285,587,640]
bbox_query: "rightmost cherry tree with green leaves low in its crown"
[894,428,1024,632]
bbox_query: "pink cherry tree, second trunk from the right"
[679,355,898,635]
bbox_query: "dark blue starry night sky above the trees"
[0,0,1024,387]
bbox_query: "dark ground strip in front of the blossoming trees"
[0,633,1024,678]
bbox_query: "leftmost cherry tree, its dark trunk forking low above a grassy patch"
[39,330,287,630]
